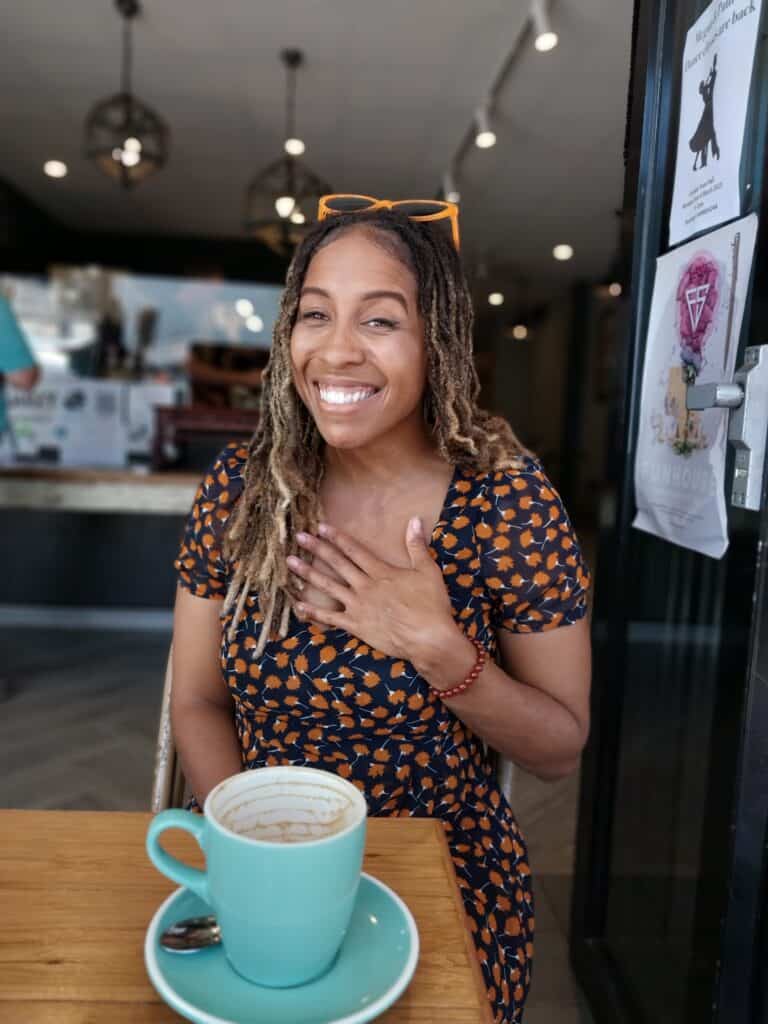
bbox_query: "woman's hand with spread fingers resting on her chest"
[288,519,453,660]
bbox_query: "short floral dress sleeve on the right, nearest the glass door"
[475,459,591,633]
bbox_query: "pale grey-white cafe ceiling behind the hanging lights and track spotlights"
[0,0,633,299]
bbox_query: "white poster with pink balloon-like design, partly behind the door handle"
[632,213,758,558]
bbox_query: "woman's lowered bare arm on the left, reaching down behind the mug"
[171,586,243,806]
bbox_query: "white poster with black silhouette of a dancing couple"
[670,0,762,246]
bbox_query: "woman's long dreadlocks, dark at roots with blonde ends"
[223,210,529,657]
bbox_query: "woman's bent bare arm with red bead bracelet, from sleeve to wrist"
[413,616,592,779]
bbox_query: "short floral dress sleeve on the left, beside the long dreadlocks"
[173,444,248,598]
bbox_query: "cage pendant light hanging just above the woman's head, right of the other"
[245,49,333,254]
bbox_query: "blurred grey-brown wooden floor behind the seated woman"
[0,627,592,1024]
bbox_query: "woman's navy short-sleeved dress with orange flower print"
[175,444,589,1024]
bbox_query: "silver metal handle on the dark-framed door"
[685,345,768,511]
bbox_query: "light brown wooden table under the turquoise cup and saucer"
[0,810,492,1024]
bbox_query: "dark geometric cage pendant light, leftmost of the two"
[84,0,170,188]
